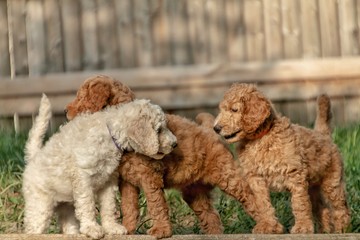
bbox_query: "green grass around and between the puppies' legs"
[0,124,360,234]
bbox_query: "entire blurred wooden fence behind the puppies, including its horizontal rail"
[0,0,360,130]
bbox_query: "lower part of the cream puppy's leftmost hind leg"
[24,187,54,234]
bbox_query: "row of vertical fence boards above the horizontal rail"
[0,0,360,76]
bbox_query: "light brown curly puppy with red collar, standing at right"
[214,84,350,233]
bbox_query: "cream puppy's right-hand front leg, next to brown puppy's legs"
[99,172,127,235]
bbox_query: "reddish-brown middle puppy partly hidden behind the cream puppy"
[67,77,283,238]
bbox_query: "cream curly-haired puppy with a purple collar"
[23,95,176,239]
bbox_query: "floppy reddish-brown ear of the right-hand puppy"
[242,93,271,133]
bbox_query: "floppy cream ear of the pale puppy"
[127,117,159,156]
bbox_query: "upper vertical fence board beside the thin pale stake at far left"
[8,0,29,76]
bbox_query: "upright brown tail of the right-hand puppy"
[314,94,332,135]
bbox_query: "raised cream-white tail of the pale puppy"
[25,94,52,162]
